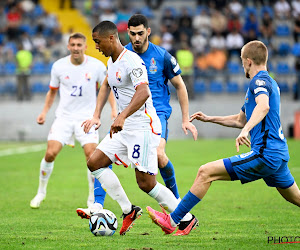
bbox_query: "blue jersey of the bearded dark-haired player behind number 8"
[125,42,181,118]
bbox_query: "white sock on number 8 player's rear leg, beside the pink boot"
[148,182,192,223]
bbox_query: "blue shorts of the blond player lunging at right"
[223,151,295,188]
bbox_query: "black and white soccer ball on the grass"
[89,209,118,236]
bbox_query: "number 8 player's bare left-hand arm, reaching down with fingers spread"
[81,77,110,133]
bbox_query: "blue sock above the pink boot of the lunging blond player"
[170,191,201,224]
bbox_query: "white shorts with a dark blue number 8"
[97,130,160,175]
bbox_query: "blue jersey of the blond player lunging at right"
[242,71,289,166]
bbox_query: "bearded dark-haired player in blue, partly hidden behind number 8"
[77,14,197,220]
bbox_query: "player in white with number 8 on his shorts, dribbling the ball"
[82,21,192,235]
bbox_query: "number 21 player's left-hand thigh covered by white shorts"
[48,118,74,146]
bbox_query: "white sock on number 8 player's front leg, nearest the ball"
[92,167,131,214]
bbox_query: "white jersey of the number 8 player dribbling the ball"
[107,49,161,134]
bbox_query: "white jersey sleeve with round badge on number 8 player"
[127,55,149,88]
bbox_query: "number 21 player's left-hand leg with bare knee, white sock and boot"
[30,140,63,208]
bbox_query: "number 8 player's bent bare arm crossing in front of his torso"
[110,83,151,137]
